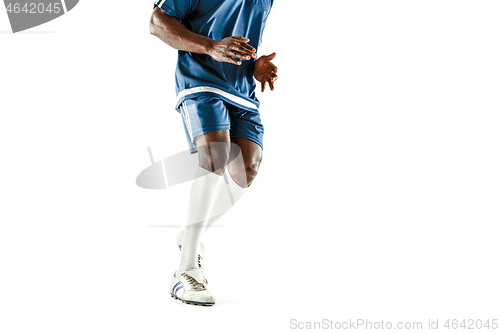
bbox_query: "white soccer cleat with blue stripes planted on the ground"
[170,269,215,306]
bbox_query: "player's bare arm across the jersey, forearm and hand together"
[149,7,256,65]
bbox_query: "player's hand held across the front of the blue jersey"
[208,36,256,65]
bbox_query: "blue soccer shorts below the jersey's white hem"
[177,95,264,153]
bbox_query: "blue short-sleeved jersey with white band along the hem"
[155,0,274,110]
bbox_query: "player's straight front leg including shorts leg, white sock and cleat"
[170,96,231,305]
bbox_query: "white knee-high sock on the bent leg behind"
[205,170,248,230]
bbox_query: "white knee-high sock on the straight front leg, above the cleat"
[177,167,223,274]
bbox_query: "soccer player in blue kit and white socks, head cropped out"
[150,0,278,305]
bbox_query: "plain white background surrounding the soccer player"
[0,0,500,333]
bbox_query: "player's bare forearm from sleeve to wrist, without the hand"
[149,7,213,54]
